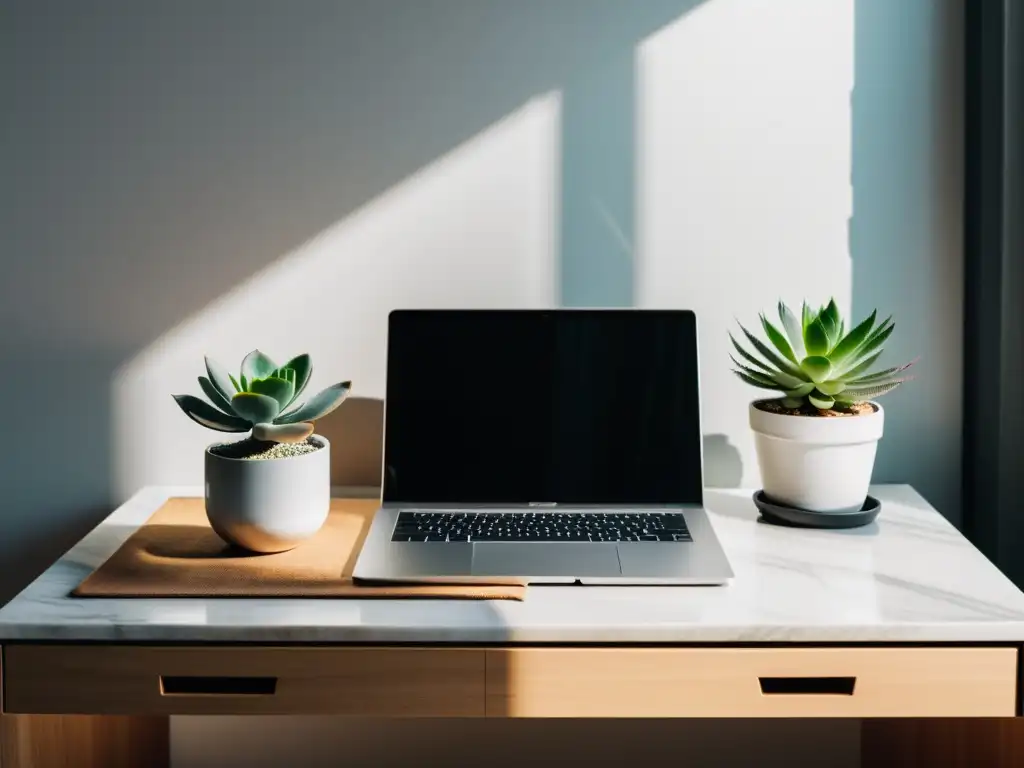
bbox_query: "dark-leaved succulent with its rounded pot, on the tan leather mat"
[174,349,351,552]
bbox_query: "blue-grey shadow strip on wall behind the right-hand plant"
[850,0,964,525]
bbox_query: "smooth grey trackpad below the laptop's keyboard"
[473,542,622,579]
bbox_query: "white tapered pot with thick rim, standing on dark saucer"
[750,402,885,512]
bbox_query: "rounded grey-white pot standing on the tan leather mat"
[199,435,331,553]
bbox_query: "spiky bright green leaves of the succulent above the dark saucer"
[729,299,913,411]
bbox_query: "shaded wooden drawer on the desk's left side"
[3,645,484,717]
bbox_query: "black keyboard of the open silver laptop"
[391,512,693,542]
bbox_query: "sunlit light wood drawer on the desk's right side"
[486,648,1017,718]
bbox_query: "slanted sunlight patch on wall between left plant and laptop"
[112,92,560,499]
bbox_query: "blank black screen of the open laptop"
[383,309,701,505]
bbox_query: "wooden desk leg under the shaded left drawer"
[0,715,170,768]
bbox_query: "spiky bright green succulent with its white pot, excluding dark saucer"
[729,299,913,512]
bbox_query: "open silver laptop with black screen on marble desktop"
[353,309,732,585]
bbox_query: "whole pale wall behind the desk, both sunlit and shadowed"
[0,0,962,766]
